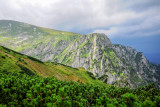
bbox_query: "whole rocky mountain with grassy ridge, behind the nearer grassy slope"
[0,20,160,88]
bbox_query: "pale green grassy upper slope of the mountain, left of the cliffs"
[0,20,81,52]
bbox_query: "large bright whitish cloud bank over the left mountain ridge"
[0,0,134,28]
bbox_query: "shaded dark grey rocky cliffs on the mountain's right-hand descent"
[113,45,160,87]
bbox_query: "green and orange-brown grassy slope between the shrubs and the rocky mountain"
[0,46,107,86]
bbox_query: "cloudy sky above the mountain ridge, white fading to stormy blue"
[0,0,160,63]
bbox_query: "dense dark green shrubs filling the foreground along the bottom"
[0,73,160,107]
